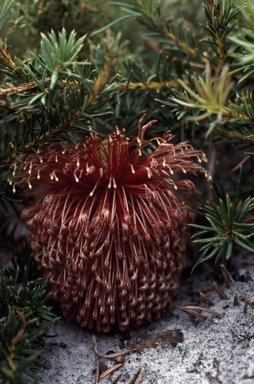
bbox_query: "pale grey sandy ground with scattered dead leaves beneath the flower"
[31,255,254,384]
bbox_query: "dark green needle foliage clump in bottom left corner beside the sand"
[0,265,56,384]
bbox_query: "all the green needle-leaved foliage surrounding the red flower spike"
[0,0,254,382]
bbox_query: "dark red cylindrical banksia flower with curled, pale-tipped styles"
[12,121,206,332]
